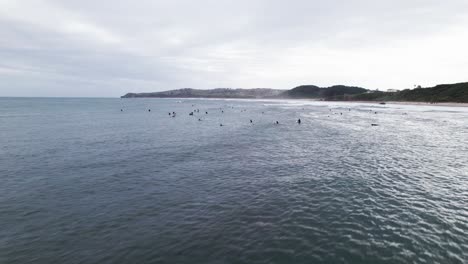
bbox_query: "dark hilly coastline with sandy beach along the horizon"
[122,83,468,103]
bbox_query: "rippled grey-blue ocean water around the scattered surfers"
[0,98,468,264]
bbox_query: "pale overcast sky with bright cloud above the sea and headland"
[0,0,468,97]
